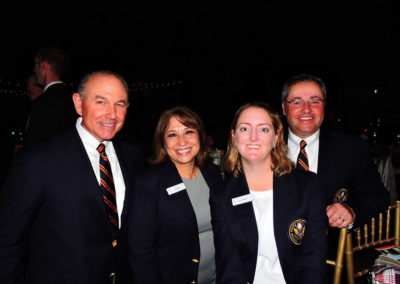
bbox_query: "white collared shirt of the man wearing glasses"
[288,129,320,173]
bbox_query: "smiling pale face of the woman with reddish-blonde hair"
[232,107,278,167]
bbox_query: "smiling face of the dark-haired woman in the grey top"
[164,116,200,168]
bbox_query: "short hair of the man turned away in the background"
[35,47,69,78]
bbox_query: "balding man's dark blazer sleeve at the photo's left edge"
[0,149,42,283]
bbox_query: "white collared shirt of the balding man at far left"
[76,117,125,227]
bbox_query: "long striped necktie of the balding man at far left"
[97,143,119,230]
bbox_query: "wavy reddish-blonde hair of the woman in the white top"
[225,101,294,177]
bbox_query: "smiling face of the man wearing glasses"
[282,81,325,139]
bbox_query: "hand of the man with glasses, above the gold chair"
[326,202,354,228]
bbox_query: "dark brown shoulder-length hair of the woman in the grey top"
[149,106,211,167]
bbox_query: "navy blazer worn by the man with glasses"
[318,129,390,225]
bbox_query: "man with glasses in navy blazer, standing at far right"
[282,74,390,251]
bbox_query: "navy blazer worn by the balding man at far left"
[0,127,143,284]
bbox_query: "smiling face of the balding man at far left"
[73,74,128,142]
